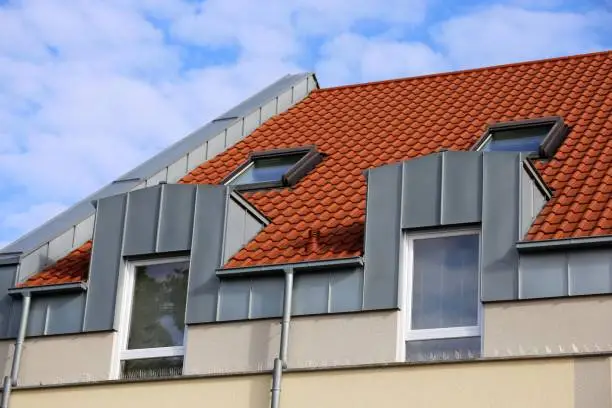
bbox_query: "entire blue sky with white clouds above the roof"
[0,0,612,248]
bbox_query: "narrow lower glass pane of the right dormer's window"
[406,337,480,361]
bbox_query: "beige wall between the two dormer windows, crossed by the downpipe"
[185,311,400,374]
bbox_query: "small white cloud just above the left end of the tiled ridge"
[316,34,448,84]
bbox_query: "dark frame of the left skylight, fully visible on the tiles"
[221,146,323,191]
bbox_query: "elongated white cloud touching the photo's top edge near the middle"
[174,0,427,49]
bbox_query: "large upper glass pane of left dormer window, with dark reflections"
[128,262,189,349]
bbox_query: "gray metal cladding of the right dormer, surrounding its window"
[364,151,544,309]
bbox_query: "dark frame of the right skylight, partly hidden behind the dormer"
[472,116,569,158]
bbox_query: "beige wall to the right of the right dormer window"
[483,296,612,357]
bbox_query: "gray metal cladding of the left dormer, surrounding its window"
[84,184,265,331]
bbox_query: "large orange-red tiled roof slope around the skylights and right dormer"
[19,52,612,286]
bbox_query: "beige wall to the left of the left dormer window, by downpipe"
[0,332,115,386]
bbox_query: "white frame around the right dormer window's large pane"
[403,228,482,346]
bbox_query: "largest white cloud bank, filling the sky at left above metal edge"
[0,0,300,245]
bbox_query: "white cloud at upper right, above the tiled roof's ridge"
[433,6,612,67]
